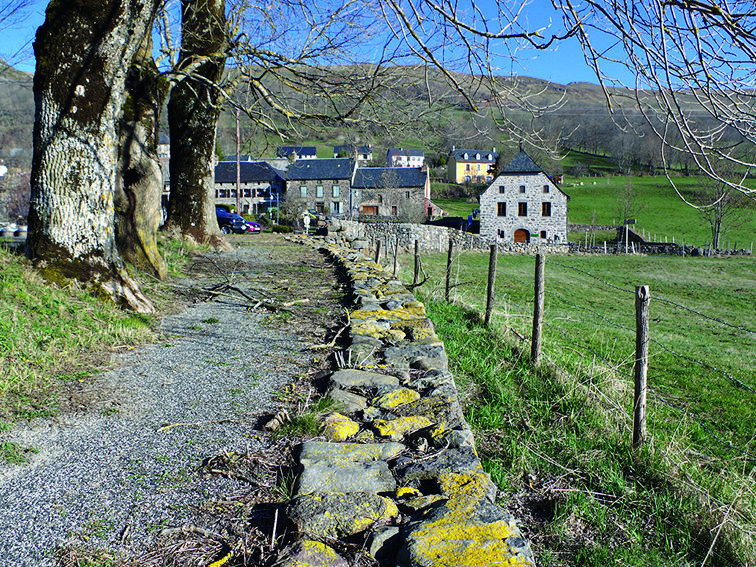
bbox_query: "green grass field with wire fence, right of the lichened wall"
[392,252,756,565]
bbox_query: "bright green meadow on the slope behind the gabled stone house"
[433,176,756,248]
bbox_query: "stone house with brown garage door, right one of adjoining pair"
[352,167,433,221]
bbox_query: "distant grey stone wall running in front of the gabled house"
[318,219,568,255]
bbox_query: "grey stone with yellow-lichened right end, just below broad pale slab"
[286,493,399,538]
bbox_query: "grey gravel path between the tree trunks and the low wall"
[0,241,328,567]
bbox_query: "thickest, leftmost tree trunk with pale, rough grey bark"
[27,0,157,312]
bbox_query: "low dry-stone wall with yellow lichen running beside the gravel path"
[281,236,534,567]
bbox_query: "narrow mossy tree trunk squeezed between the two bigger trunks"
[114,35,167,280]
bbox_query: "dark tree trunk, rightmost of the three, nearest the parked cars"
[168,0,228,246]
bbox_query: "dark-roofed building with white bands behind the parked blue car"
[215,161,286,213]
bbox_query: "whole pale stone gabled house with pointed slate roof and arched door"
[480,151,569,243]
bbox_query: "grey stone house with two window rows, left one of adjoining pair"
[286,158,357,216]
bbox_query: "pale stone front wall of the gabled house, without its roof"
[480,173,567,243]
